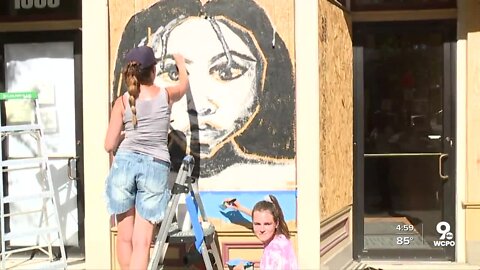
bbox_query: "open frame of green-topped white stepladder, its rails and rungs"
[0,91,67,269]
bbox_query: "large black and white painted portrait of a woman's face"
[113,0,295,190]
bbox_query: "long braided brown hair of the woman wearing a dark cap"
[123,61,153,127]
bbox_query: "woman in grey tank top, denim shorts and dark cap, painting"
[105,46,189,269]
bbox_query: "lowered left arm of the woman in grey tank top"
[104,96,124,153]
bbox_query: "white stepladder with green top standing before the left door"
[0,91,67,269]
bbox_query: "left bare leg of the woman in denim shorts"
[117,208,135,270]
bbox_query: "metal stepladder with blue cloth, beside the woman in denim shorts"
[148,155,223,270]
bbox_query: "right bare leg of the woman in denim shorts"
[130,212,155,270]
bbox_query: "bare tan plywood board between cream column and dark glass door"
[318,0,353,219]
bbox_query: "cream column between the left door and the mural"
[82,0,110,269]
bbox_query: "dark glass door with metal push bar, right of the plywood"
[353,21,456,261]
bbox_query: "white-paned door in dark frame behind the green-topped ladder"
[0,31,85,257]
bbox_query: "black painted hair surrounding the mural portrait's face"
[112,0,295,177]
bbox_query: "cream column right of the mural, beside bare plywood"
[295,0,321,269]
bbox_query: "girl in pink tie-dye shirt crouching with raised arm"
[224,195,298,270]
